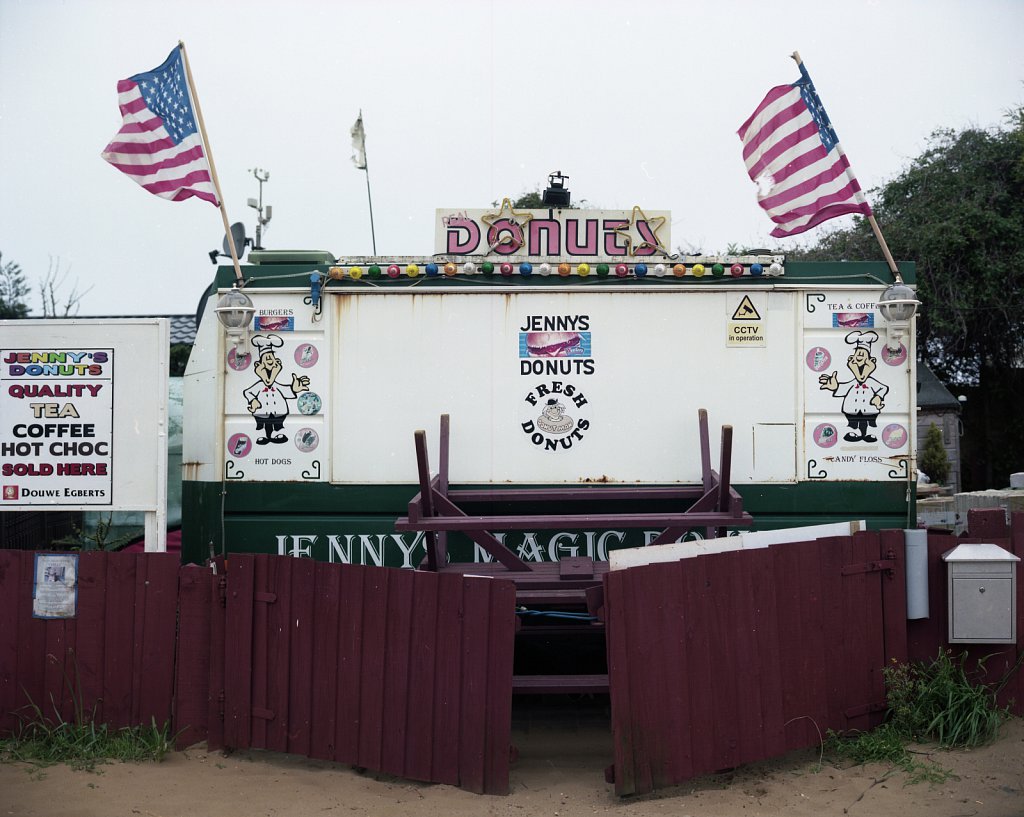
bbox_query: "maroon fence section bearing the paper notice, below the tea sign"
[0,551,181,731]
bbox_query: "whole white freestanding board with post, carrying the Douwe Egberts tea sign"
[0,318,169,547]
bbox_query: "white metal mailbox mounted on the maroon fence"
[942,545,1020,644]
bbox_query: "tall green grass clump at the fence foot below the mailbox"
[825,650,1017,783]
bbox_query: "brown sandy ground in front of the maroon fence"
[0,707,1024,817]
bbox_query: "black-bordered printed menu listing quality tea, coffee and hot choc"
[0,347,114,510]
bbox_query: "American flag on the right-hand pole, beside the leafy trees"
[737,65,871,239]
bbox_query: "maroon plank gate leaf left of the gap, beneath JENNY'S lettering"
[210,555,515,793]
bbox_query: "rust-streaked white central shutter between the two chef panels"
[329,290,798,484]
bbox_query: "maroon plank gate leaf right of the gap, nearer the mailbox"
[605,531,906,794]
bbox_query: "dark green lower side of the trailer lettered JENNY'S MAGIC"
[182,482,906,567]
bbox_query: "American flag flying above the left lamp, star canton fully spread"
[101,47,219,205]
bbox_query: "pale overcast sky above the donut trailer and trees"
[0,0,1024,315]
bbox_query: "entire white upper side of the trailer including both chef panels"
[218,287,912,486]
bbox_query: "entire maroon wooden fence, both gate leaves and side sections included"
[0,518,1024,793]
